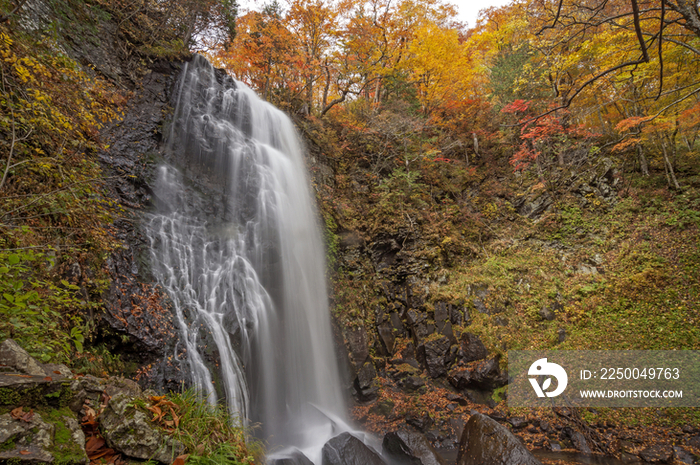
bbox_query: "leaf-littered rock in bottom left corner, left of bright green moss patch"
[0,413,55,463]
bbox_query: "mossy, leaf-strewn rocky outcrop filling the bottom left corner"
[0,340,184,464]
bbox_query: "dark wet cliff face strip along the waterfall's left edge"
[99,61,186,391]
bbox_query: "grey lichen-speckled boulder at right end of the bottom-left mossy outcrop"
[98,392,185,464]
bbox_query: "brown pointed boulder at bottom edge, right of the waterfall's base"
[457,414,541,465]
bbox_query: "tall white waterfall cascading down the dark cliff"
[147,56,356,464]
